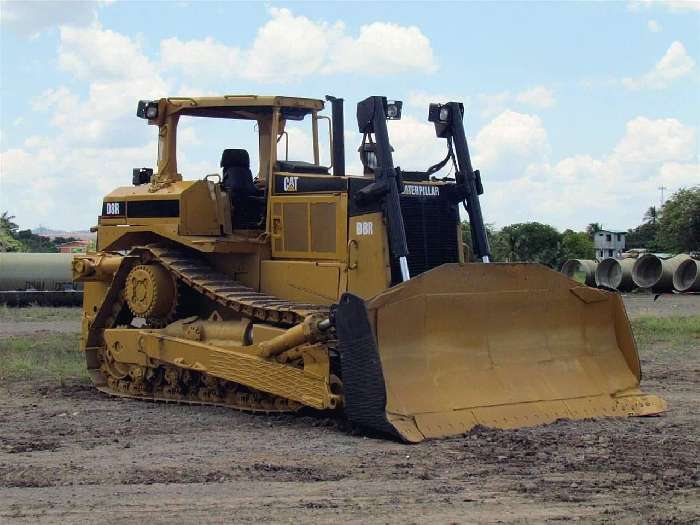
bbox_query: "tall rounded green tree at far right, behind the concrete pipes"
[656,186,700,252]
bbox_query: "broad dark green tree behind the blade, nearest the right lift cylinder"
[498,222,562,268]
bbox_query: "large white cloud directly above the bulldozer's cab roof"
[161,7,437,83]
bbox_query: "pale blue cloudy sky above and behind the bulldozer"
[0,1,700,229]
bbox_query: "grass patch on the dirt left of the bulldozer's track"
[0,334,88,382]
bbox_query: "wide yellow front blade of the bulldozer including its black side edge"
[335,263,666,442]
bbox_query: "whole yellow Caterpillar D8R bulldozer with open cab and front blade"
[73,95,665,442]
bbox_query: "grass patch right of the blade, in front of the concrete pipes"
[632,315,700,349]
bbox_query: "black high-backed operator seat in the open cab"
[221,149,265,230]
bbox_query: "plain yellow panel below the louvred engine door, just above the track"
[260,261,342,304]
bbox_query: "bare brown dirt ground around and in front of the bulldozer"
[0,296,700,523]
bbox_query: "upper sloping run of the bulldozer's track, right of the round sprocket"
[143,246,329,326]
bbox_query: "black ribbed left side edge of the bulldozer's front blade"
[335,293,401,438]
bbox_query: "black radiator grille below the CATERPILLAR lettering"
[391,195,460,284]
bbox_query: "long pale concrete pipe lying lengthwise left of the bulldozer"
[0,253,75,292]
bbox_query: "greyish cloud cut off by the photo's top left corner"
[0,0,100,36]
